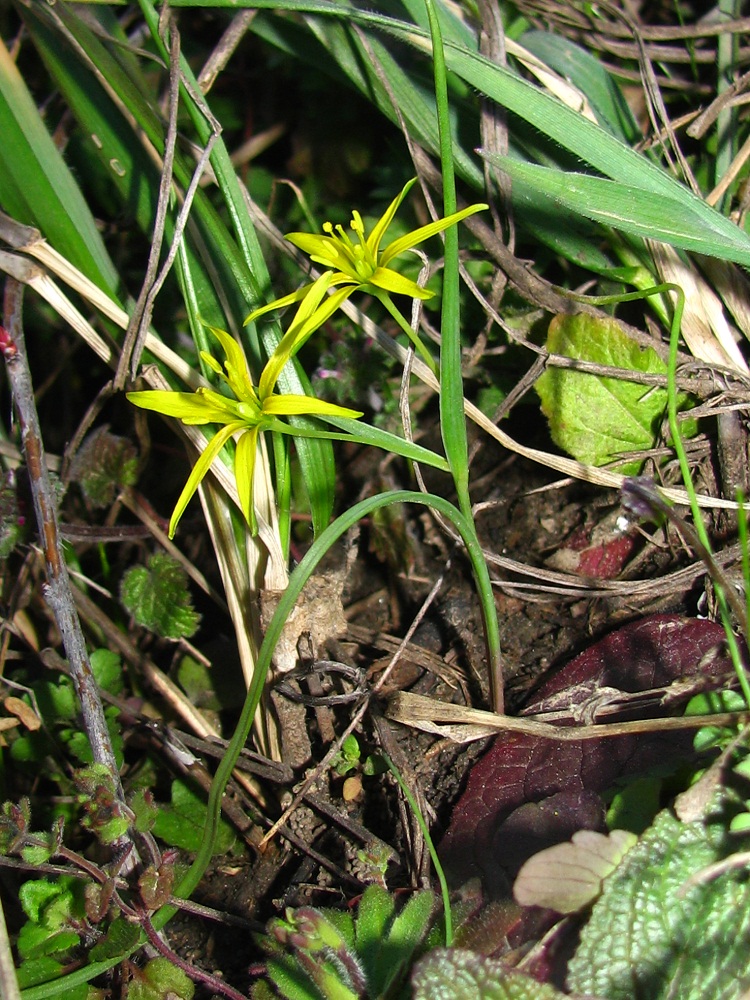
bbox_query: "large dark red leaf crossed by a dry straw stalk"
[440,615,744,898]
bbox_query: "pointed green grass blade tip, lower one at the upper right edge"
[482,152,750,265]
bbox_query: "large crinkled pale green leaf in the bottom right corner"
[568,810,750,1000]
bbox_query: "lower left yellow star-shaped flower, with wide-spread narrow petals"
[127,274,362,538]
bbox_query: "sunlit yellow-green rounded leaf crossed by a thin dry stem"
[536,314,692,475]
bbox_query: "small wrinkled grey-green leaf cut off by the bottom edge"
[411,948,564,1000]
